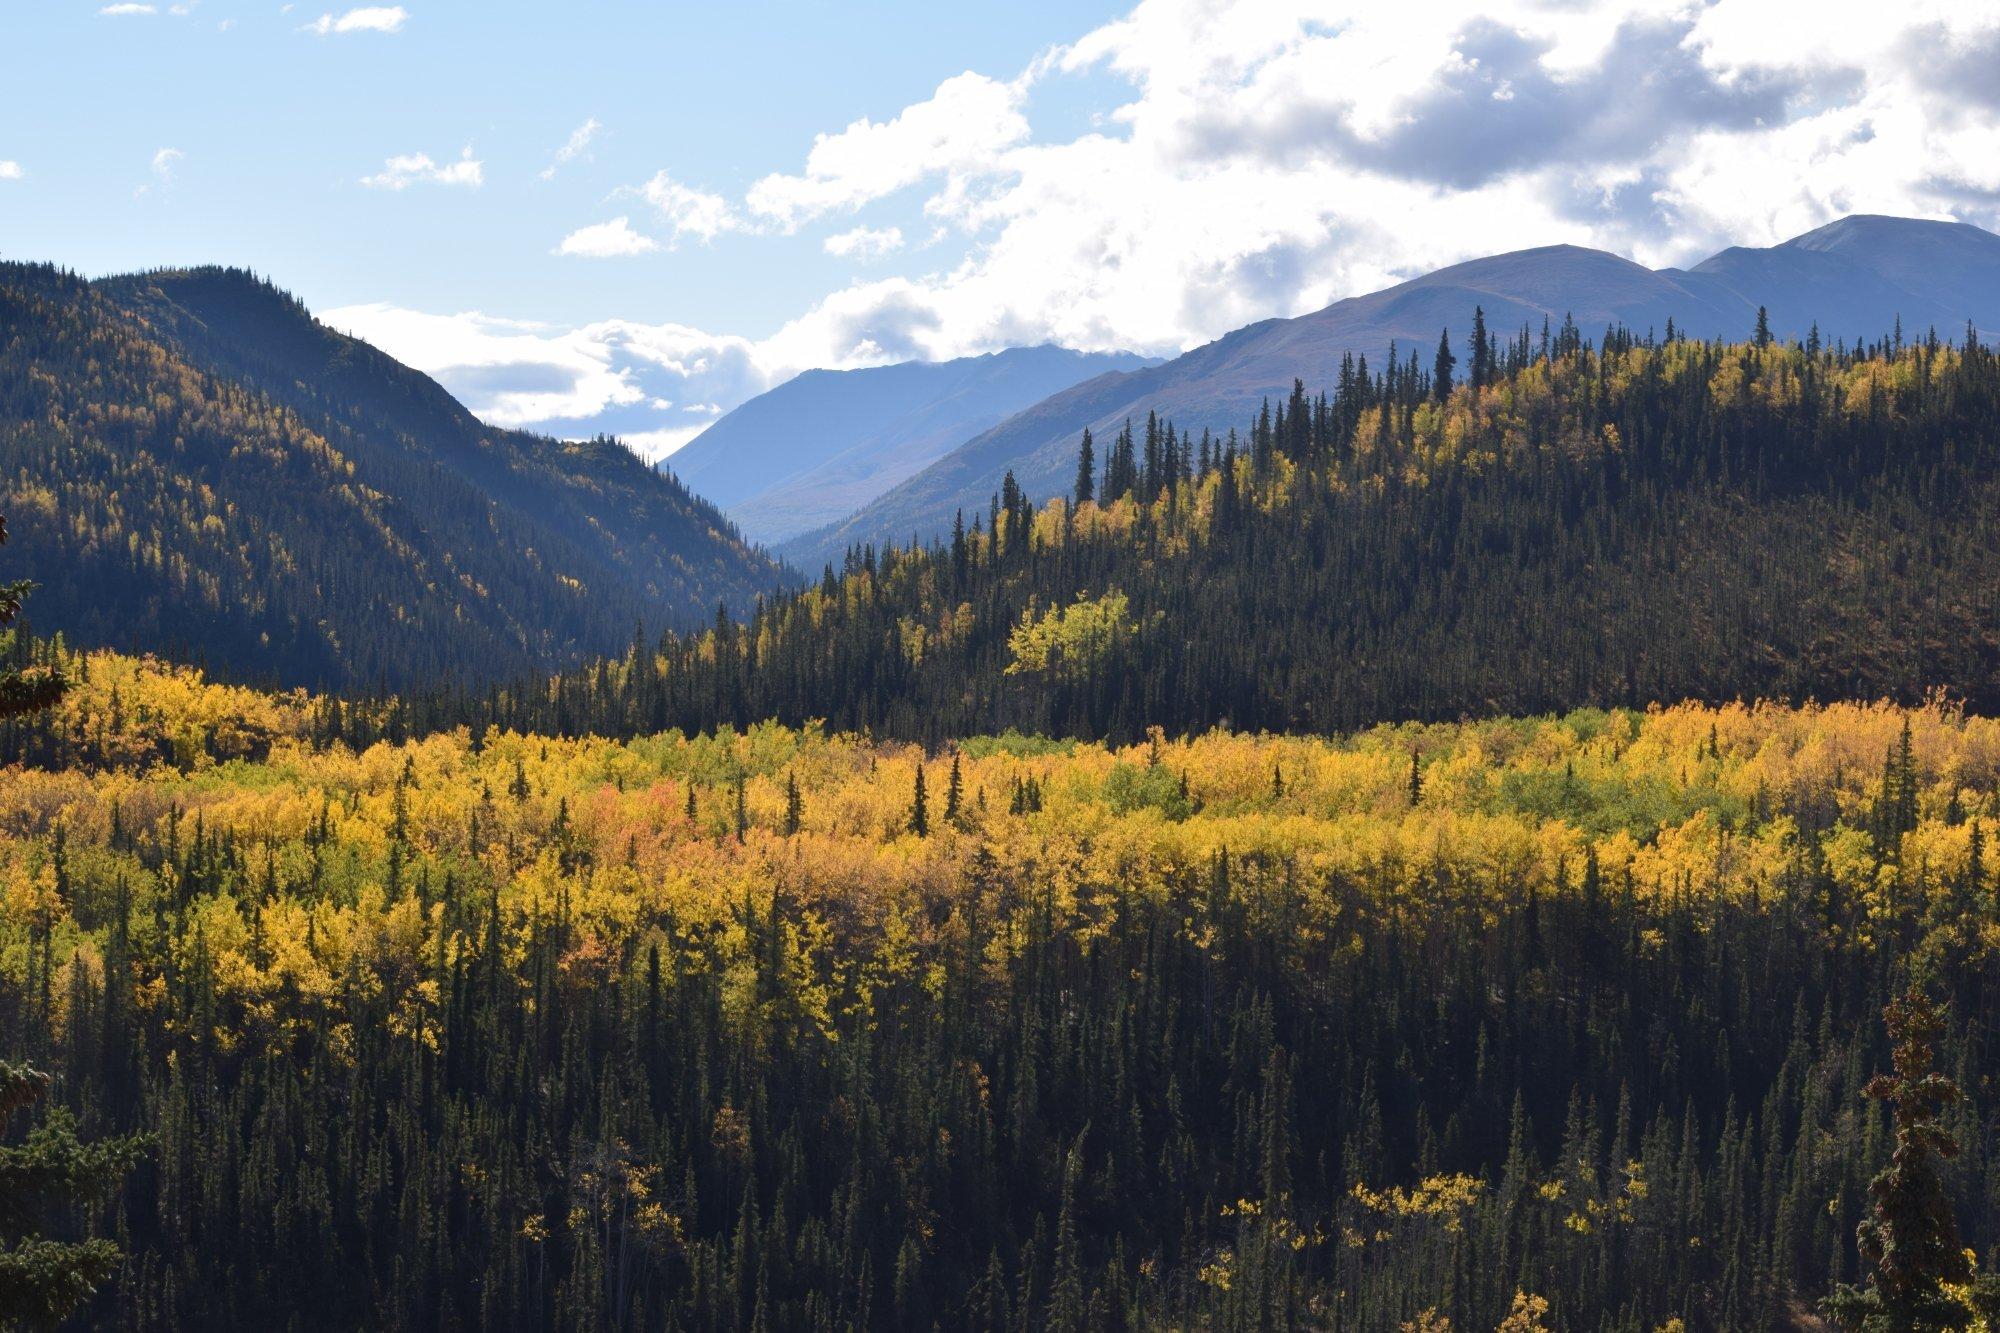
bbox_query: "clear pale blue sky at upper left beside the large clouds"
[0,0,1114,334]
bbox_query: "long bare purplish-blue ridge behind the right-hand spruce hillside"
[778,216,2000,570]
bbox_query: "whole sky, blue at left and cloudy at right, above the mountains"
[11,0,2000,456]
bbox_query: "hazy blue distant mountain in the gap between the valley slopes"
[668,346,1154,542]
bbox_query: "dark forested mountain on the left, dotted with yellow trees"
[0,264,784,687]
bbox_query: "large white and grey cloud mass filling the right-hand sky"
[344,0,2000,440]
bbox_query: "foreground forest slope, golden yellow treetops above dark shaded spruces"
[0,642,2000,1333]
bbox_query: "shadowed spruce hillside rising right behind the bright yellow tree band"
[398,318,2000,743]
